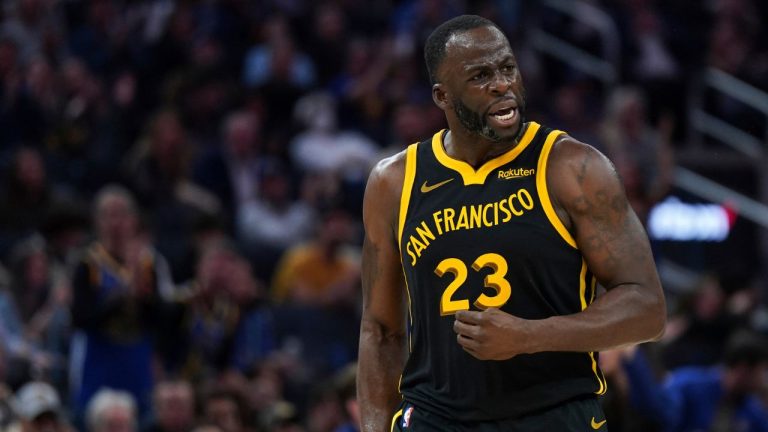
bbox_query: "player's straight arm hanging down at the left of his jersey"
[357,152,406,432]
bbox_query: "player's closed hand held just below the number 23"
[453,309,530,360]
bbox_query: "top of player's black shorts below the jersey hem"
[391,398,608,432]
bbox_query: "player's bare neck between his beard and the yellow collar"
[443,124,528,169]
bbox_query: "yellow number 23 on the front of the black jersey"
[435,253,512,315]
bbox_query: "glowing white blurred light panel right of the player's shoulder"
[648,196,736,242]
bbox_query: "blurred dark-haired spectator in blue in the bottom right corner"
[624,331,768,432]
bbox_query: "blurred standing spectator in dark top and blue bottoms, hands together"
[70,185,170,413]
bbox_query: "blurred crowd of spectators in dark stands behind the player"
[0,0,768,432]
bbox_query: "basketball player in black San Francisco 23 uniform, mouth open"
[358,16,665,432]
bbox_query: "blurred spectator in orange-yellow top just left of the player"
[272,210,360,384]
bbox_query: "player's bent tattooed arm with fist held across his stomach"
[454,136,666,359]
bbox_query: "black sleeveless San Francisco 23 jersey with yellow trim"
[398,122,606,421]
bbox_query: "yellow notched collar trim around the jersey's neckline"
[432,122,540,186]
